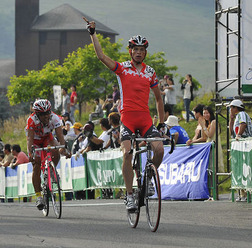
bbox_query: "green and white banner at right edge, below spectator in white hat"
[230,138,252,191]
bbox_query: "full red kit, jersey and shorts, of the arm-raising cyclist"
[112,61,159,140]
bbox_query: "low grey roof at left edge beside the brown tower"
[0,59,15,88]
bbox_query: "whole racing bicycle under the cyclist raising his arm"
[127,133,174,232]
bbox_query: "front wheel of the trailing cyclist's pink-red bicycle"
[48,163,62,219]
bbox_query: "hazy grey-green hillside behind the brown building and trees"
[0,0,214,91]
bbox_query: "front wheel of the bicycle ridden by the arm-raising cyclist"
[145,164,161,232]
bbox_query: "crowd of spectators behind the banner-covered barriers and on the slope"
[0,74,252,201]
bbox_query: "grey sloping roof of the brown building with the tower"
[31,4,118,35]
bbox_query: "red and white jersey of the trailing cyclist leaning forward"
[25,112,61,142]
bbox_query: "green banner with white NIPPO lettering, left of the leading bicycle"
[87,149,124,188]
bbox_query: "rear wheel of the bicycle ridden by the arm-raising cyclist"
[127,171,141,228]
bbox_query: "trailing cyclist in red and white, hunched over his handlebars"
[26,99,67,210]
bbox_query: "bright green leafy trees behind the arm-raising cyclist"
[7,35,177,109]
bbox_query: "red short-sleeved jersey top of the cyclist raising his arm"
[112,61,158,113]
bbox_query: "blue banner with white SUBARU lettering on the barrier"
[142,143,212,200]
